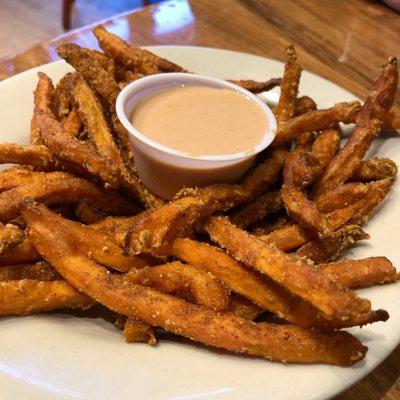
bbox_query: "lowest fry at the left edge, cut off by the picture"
[0,279,95,316]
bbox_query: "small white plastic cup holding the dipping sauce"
[116,73,276,199]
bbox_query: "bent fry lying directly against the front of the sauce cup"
[127,150,286,254]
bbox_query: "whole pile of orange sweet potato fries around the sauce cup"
[0,26,399,366]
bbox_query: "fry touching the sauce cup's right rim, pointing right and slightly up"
[272,101,361,147]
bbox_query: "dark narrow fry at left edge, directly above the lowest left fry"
[0,261,62,281]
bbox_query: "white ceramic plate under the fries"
[0,46,400,400]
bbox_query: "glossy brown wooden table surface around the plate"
[0,0,400,400]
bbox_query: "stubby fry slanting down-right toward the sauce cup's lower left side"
[36,114,120,188]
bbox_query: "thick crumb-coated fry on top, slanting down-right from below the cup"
[205,217,371,321]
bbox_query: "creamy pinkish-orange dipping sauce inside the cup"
[131,86,268,156]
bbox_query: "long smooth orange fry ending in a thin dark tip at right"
[170,239,388,330]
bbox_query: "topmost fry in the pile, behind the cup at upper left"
[93,26,158,75]
